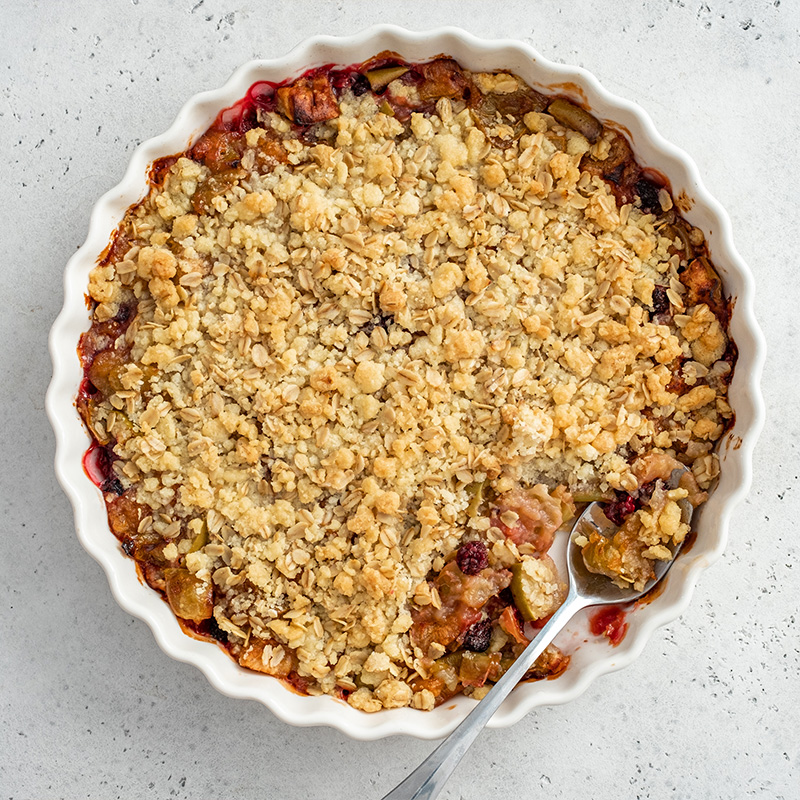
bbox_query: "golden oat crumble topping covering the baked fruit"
[78,57,731,711]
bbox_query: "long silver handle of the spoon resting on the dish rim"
[383,591,588,800]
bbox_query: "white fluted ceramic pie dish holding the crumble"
[47,27,763,739]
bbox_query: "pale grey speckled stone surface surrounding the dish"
[0,0,800,800]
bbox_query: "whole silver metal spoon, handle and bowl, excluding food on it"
[383,468,693,800]
